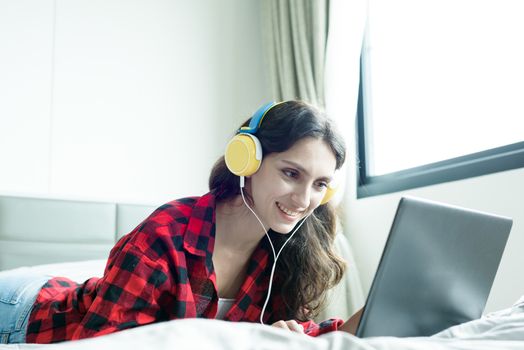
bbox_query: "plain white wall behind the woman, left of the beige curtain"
[0,0,270,204]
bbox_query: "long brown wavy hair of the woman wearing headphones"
[209,101,346,320]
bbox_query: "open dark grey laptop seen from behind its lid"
[356,197,512,337]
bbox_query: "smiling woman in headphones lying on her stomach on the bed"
[0,101,356,343]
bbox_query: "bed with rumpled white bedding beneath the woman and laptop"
[0,260,524,350]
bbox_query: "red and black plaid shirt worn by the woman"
[26,194,343,343]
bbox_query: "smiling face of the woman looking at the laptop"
[248,137,336,233]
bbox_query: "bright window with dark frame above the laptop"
[357,0,524,197]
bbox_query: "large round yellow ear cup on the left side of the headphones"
[224,134,262,176]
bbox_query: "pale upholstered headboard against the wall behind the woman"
[0,196,155,270]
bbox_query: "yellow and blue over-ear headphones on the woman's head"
[224,102,336,205]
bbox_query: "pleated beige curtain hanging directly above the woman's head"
[261,0,329,108]
